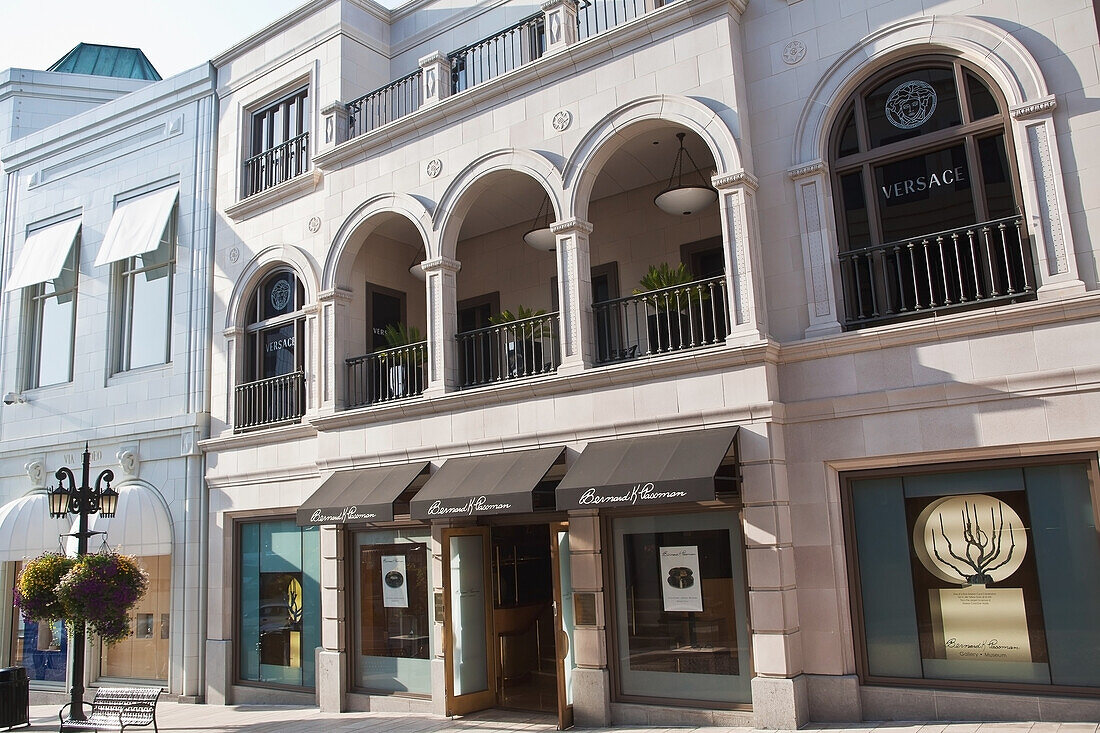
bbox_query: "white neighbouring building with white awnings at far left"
[0,45,217,699]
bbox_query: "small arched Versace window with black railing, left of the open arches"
[233,269,306,431]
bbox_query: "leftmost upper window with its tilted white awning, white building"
[6,217,80,387]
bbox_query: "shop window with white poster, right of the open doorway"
[613,512,750,702]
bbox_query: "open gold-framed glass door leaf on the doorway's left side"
[443,527,496,715]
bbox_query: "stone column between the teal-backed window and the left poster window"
[316,525,348,712]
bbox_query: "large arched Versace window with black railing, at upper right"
[829,57,1035,328]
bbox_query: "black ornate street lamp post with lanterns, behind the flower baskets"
[50,444,119,720]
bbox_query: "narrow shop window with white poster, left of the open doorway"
[355,527,432,694]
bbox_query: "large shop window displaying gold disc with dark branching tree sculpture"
[849,463,1100,687]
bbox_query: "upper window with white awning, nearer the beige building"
[96,186,178,372]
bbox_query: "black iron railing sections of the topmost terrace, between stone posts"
[345,0,666,141]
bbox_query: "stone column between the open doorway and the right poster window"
[569,510,612,727]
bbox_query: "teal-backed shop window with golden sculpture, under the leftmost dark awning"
[239,519,321,687]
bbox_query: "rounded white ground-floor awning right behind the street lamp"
[65,484,172,557]
